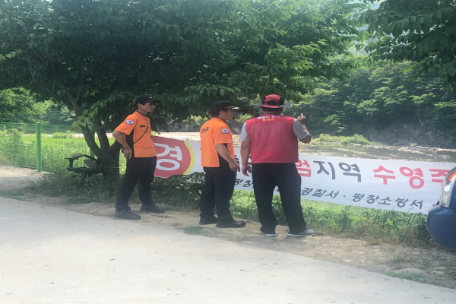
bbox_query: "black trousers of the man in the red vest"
[252,164,306,233]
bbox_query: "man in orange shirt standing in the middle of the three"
[199,100,245,228]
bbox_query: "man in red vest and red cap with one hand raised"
[240,94,314,237]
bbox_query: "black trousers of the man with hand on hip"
[116,156,157,211]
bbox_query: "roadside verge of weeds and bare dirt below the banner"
[0,166,456,289]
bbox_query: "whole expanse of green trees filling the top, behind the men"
[0,0,456,150]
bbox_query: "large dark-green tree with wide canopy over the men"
[0,0,359,175]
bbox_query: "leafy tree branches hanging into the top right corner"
[363,0,456,89]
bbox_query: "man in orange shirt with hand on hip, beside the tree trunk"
[112,95,165,220]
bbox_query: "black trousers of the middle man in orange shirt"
[200,167,236,221]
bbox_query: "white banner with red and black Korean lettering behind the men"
[152,136,456,214]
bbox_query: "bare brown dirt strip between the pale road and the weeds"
[0,166,456,289]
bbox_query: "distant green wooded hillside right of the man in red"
[286,62,456,148]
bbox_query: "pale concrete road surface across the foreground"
[0,196,456,304]
